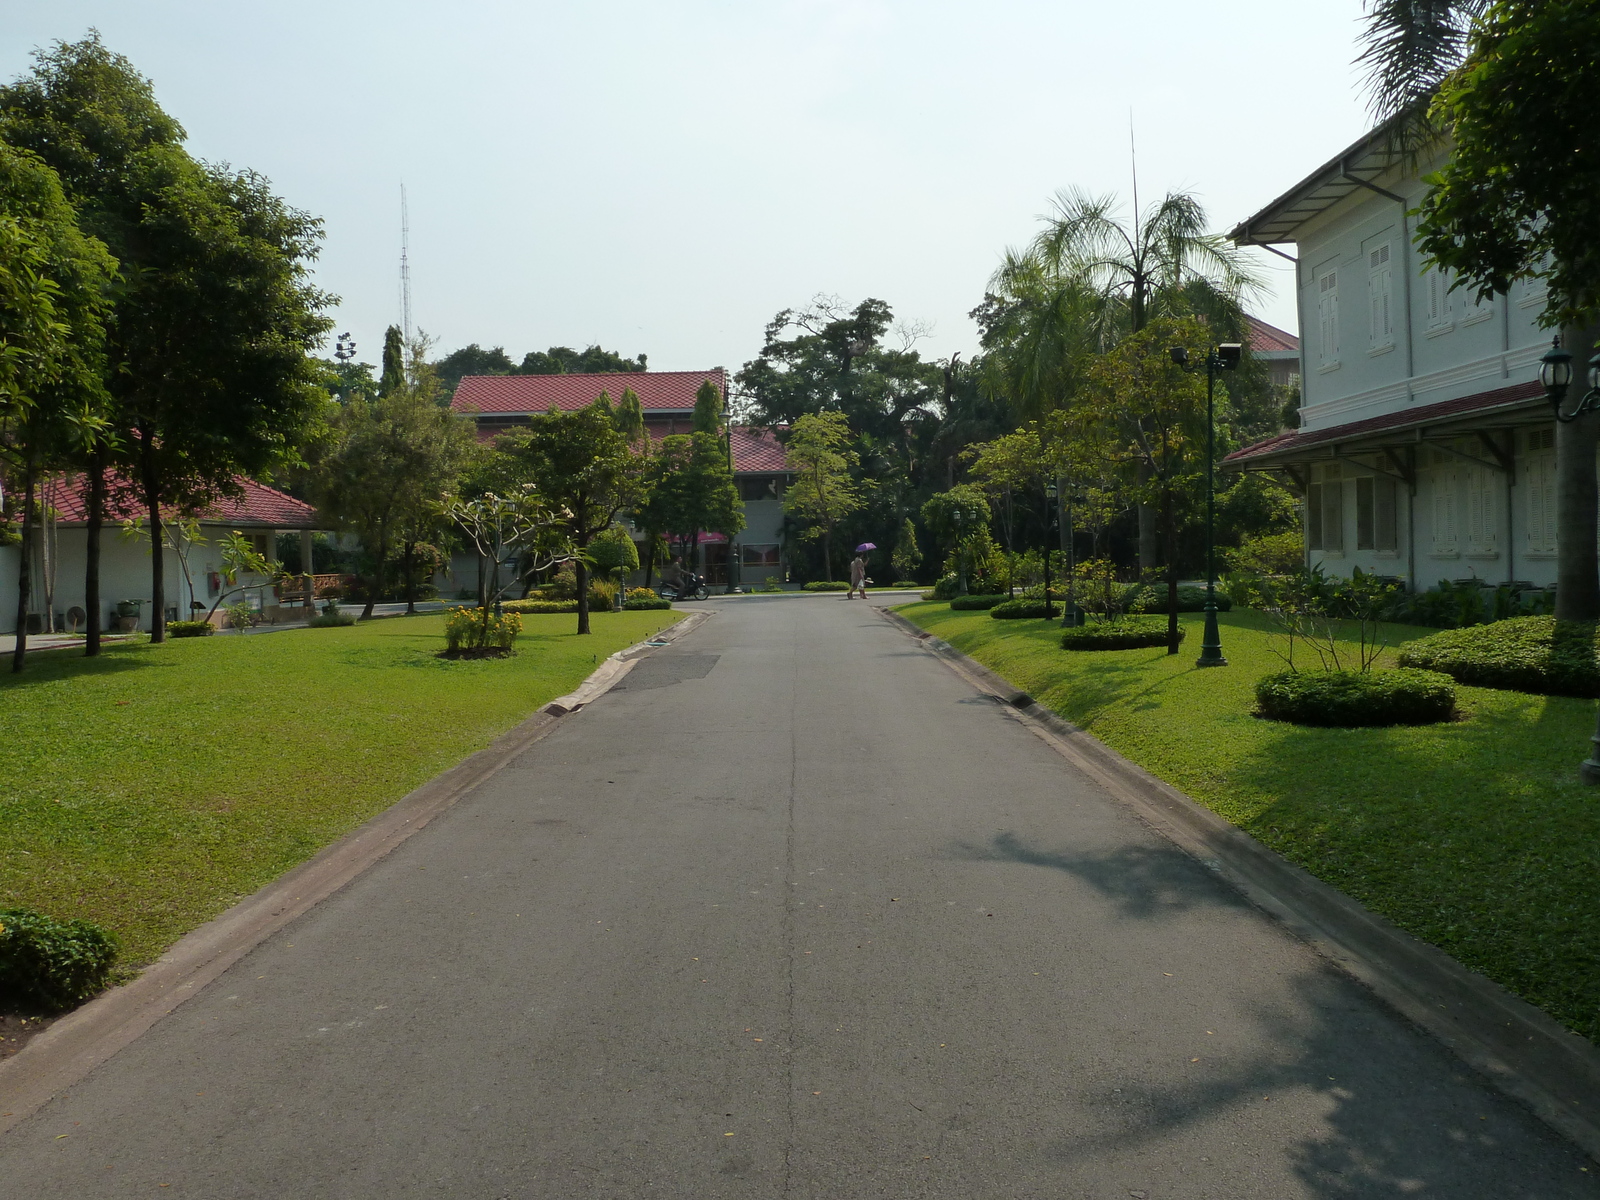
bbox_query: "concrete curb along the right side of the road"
[878,610,1600,1160]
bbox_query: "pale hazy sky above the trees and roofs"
[0,0,1366,370]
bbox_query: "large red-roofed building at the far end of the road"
[450,366,794,587]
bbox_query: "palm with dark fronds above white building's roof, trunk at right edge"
[1357,0,1600,621]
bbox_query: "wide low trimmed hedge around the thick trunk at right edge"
[1400,616,1600,698]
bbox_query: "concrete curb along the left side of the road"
[0,613,710,1134]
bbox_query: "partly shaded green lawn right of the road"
[899,603,1600,1038]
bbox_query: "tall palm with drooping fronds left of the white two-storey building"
[986,189,1261,570]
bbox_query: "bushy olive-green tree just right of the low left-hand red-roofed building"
[315,341,477,619]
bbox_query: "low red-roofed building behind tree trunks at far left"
[0,475,328,634]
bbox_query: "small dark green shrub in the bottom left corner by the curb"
[0,909,117,1011]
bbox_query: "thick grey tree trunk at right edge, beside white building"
[1555,328,1600,621]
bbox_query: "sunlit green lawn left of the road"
[0,611,683,965]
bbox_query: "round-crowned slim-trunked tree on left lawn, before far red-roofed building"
[491,405,640,634]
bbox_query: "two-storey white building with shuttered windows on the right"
[1227,131,1557,589]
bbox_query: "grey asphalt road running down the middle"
[0,595,1600,1200]
